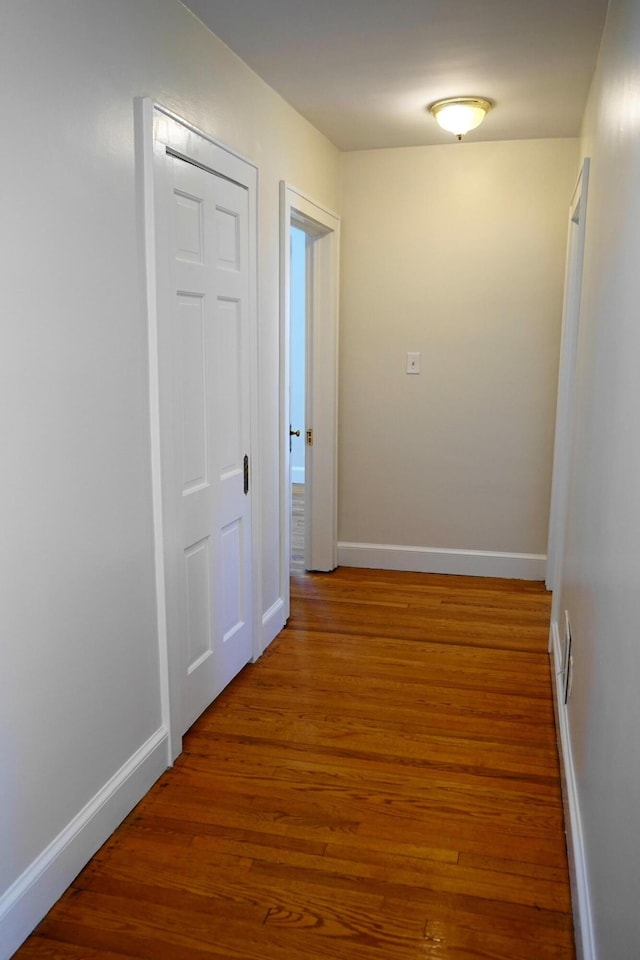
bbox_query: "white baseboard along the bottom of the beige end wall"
[338,543,547,580]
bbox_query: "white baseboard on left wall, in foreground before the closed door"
[0,727,168,960]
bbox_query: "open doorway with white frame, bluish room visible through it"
[280,183,340,622]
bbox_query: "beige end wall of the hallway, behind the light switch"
[339,140,578,554]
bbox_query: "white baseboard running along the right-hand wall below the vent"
[549,620,596,960]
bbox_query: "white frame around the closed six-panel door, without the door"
[135,97,262,764]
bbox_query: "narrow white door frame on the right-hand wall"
[545,157,590,623]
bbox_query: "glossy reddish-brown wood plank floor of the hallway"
[17,569,574,960]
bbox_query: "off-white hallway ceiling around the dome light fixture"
[182,0,607,150]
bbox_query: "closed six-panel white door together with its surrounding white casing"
[141,101,261,761]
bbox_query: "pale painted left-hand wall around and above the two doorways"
[0,0,338,940]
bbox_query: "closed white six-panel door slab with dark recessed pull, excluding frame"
[170,156,252,732]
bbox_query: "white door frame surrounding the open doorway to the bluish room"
[280,181,340,621]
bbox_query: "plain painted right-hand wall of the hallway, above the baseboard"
[560,0,640,960]
